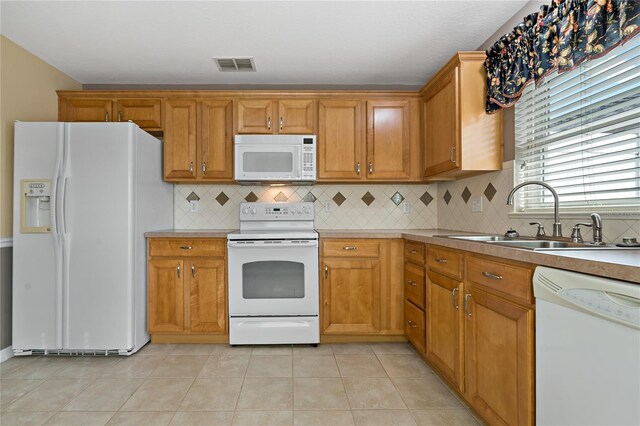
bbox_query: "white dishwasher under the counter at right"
[533,266,640,426]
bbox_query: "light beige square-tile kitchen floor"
[0,343,479,426]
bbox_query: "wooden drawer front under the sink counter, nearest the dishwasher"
[467,257,533,303]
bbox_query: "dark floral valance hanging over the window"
[485,0,640,113]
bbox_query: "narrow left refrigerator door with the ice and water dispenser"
[12,122,64,353]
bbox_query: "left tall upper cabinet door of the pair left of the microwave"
[164,99,197,180]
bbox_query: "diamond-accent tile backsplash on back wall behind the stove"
[174,184,438,229]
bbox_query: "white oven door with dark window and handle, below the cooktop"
[228,240,319,317]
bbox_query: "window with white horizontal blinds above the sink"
[514,37,640,212]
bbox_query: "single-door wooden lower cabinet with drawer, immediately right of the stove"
[320,239,404,336]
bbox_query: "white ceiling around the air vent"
[0,0,527,86]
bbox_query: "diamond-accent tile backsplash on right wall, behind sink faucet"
[434,161,640,243]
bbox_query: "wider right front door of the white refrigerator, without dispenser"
[61,123,135,350]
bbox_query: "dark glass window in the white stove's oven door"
[242,260,304,299]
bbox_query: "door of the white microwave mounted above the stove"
[235,144,302,181]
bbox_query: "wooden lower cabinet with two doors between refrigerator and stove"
[147,238,227,342]
